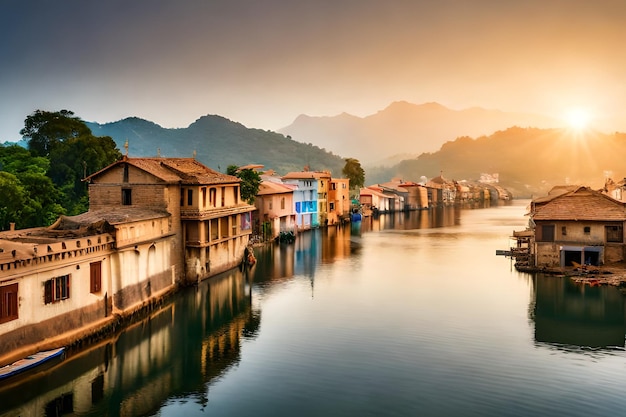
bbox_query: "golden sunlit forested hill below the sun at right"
[366,127,626,197]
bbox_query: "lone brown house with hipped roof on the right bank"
[529,187,626,267]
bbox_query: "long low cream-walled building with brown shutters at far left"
[0,208,176,364]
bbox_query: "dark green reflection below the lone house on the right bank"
[530,274,626,348]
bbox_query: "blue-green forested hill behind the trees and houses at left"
[86,115,345,176]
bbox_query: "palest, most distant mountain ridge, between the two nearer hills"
[279,101,559,165]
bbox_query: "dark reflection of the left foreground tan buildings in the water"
[0,270,255,415]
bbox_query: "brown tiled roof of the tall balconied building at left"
[86,156,240,184]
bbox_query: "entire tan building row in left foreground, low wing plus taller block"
[0,157,254,365]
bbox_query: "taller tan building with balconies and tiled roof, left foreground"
[88,157,255,282]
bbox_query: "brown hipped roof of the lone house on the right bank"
[532,187,626,221]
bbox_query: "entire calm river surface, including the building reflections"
[0,201,626,416]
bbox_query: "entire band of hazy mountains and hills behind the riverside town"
[87,102,626,197]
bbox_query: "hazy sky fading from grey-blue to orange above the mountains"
[0,0,626,142]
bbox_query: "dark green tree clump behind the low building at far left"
[0,110,121,230]
